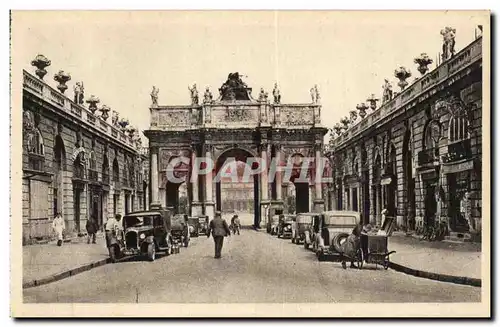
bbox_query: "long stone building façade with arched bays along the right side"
[326,37,483,239]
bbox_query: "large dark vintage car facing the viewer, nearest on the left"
[122,206,172,261]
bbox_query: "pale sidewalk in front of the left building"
[23,234,108,287]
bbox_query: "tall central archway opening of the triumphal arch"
[215,148,261,226]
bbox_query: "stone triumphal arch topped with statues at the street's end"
[144,73,327,226]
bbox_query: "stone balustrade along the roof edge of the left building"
[23,70,139,150]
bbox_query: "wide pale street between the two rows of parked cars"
[24,229,481,303]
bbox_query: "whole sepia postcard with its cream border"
[11,11,491,317]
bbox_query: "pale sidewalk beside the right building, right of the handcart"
[388,235,481,279]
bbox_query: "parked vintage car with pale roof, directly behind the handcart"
[312,211,360,260]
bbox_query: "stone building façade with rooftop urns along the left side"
[22,55,149,244]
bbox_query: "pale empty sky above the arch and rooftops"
[12,11,480,145]
